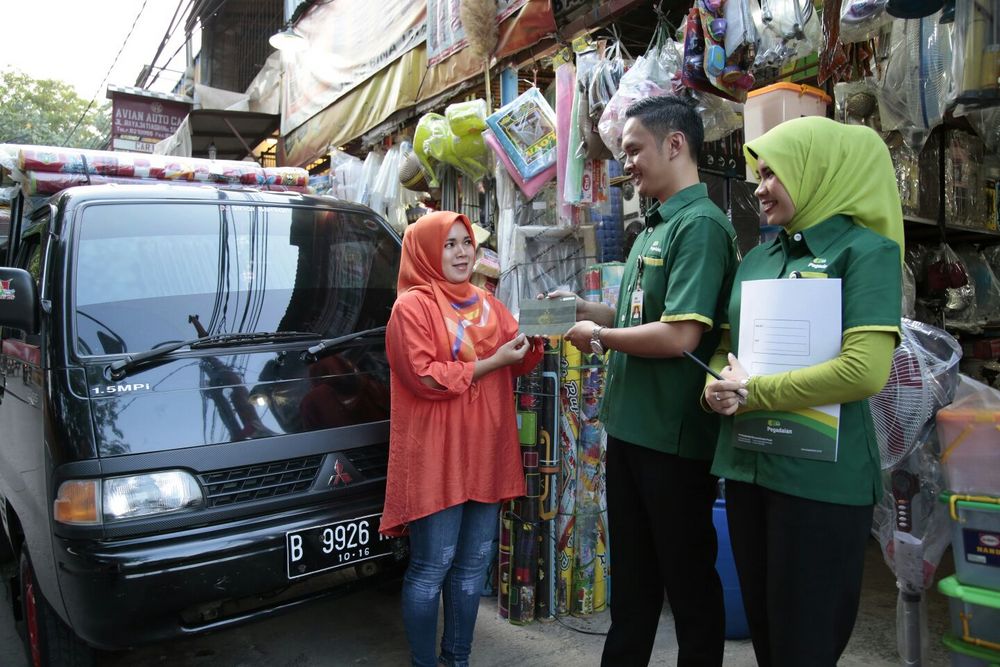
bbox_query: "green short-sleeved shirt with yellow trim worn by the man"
[601,183,738,460]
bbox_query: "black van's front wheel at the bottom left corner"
[20,551,94,667]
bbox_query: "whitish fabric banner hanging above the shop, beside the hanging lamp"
[281,0,427,134]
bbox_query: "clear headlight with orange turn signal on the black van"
[53,470,205,525]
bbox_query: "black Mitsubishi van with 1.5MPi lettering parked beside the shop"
[0,185,406,665]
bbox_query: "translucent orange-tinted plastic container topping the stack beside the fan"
[937,408,1000,496]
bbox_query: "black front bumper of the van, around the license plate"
[49,497,408,650]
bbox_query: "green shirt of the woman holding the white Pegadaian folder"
[712,215,902,505]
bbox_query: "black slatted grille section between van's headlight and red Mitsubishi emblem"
[198,456,322,507]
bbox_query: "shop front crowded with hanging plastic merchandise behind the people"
[302,0,1000,664]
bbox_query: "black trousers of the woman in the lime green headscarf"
[728,481,873,667]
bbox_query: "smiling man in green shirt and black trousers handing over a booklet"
[566,97,738,667]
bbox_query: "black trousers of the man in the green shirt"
[601,437,726,667]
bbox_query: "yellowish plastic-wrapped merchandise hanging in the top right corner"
[954,0,1000,107]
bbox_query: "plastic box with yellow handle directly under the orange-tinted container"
[942,494,1000,590]
